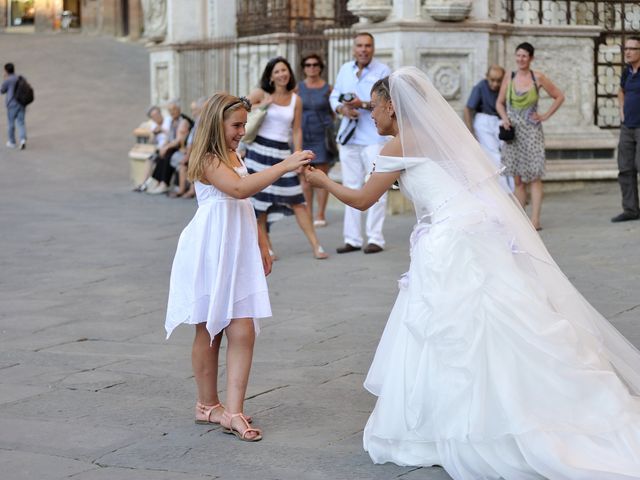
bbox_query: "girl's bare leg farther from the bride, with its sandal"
[191,323,222,422]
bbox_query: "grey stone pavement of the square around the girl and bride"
[0,34,640,480]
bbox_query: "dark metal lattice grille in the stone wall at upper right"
[502,0,640,128]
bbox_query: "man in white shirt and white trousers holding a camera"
[329,32,391,253]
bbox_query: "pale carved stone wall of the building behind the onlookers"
[151,0,616,159]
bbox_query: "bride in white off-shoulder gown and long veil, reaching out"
[306,67,640,480]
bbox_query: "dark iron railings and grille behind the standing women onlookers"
[174,0,357,102]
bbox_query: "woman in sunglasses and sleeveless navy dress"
[298,53,338,227]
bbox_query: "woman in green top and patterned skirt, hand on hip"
[496,42,564,230]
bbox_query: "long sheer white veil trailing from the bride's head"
[390,67,640,395]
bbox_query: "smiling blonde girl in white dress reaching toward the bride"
[165,93,313,442]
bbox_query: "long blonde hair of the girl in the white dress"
[187,93,251,182]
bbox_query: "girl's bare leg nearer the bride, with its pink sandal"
[225,318,258,439]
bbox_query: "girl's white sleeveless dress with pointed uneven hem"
[165,163,271,338]
